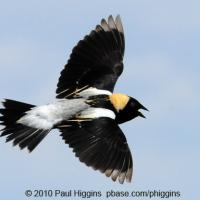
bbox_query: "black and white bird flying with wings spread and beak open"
[0,15,147,184]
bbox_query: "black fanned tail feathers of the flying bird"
[0,99,49,152]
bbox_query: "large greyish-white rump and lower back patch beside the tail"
[17,99,89,130]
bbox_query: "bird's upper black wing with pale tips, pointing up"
[56,15,125,98]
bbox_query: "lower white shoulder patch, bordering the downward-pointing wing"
[79,108,116,119]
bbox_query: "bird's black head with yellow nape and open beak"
[111,94,148,124]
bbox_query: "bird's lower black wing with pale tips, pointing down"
[59,117,133,183]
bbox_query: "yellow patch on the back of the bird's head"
[109,93,130,112]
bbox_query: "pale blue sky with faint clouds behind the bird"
[0,0,200,200]
